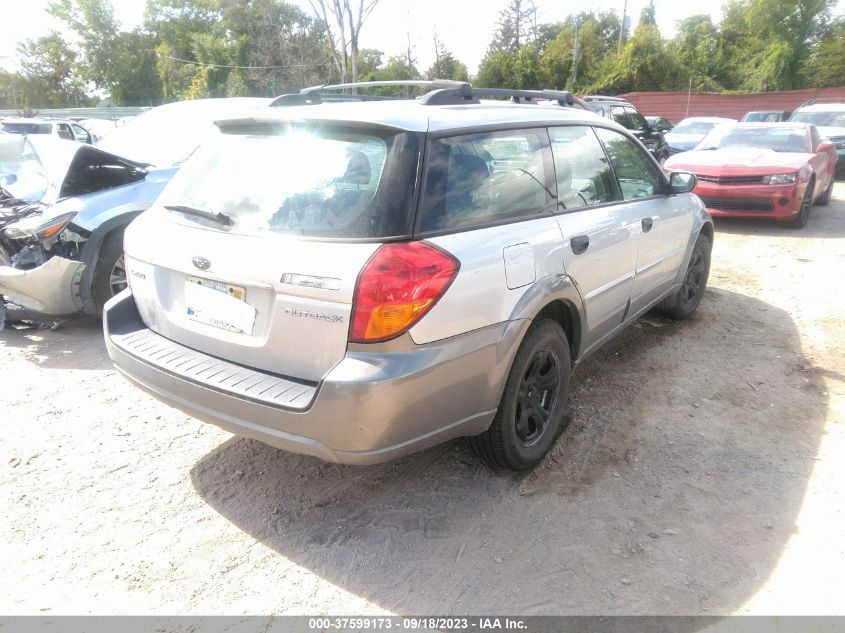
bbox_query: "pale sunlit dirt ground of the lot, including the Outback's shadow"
[0,183,845,615]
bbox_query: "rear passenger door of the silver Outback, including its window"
[549,126,640,350]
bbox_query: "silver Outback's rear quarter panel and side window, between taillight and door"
[411,128,564,343]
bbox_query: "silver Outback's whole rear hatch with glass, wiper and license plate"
[125,122,420,381]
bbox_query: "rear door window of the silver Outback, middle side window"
[549,126,621,211]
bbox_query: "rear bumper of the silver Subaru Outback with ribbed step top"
[103,290,528,464]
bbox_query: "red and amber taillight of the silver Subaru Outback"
[349,242,460,343]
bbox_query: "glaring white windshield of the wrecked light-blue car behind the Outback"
[97,99,267,167]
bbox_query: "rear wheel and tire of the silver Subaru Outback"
[469,319,572,470]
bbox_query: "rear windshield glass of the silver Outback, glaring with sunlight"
[160,125,420,239]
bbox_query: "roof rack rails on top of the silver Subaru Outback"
[270,79,585,108]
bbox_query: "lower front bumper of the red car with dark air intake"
[695,181,803,220]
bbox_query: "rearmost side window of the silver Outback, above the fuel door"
[417,130,552,232]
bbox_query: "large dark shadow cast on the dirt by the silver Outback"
[191,290,827,615]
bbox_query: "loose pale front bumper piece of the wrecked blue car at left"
[0,257,85,316]
